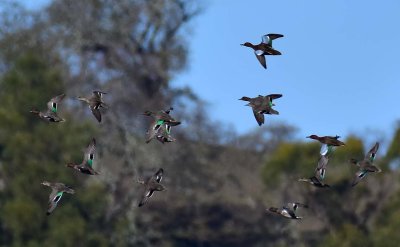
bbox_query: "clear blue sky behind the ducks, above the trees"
[21,0,400,143]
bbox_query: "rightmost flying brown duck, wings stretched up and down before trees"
[350,142,382,187]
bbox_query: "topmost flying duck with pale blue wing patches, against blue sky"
[241,33,283,69]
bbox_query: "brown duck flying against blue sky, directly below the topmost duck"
[239,94,282,126]
